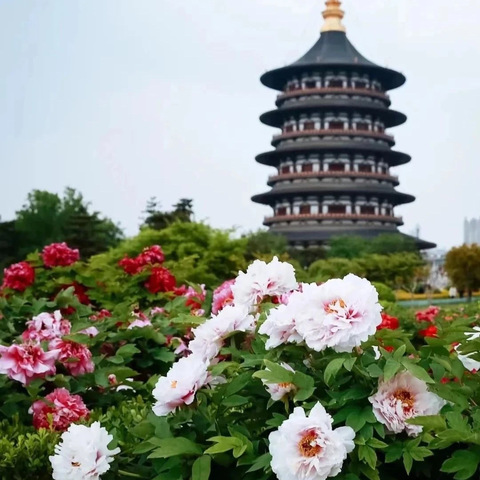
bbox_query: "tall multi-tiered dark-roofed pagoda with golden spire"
[252,0,435,249]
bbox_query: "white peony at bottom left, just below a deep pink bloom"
[50,422,120,480]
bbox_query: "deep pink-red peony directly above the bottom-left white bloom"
[30,388,90,432]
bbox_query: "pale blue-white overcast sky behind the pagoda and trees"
[0,0,480,247]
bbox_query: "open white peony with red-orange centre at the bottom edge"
[268,403,355,480]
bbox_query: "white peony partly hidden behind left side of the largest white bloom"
[258,292,306,350]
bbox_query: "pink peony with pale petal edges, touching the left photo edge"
[0,343,58,385]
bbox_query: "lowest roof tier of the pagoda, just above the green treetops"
[269,225,437,250]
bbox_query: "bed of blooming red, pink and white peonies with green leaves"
[0,243,480,480]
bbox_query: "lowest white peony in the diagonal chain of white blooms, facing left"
[152,355,208,417]
